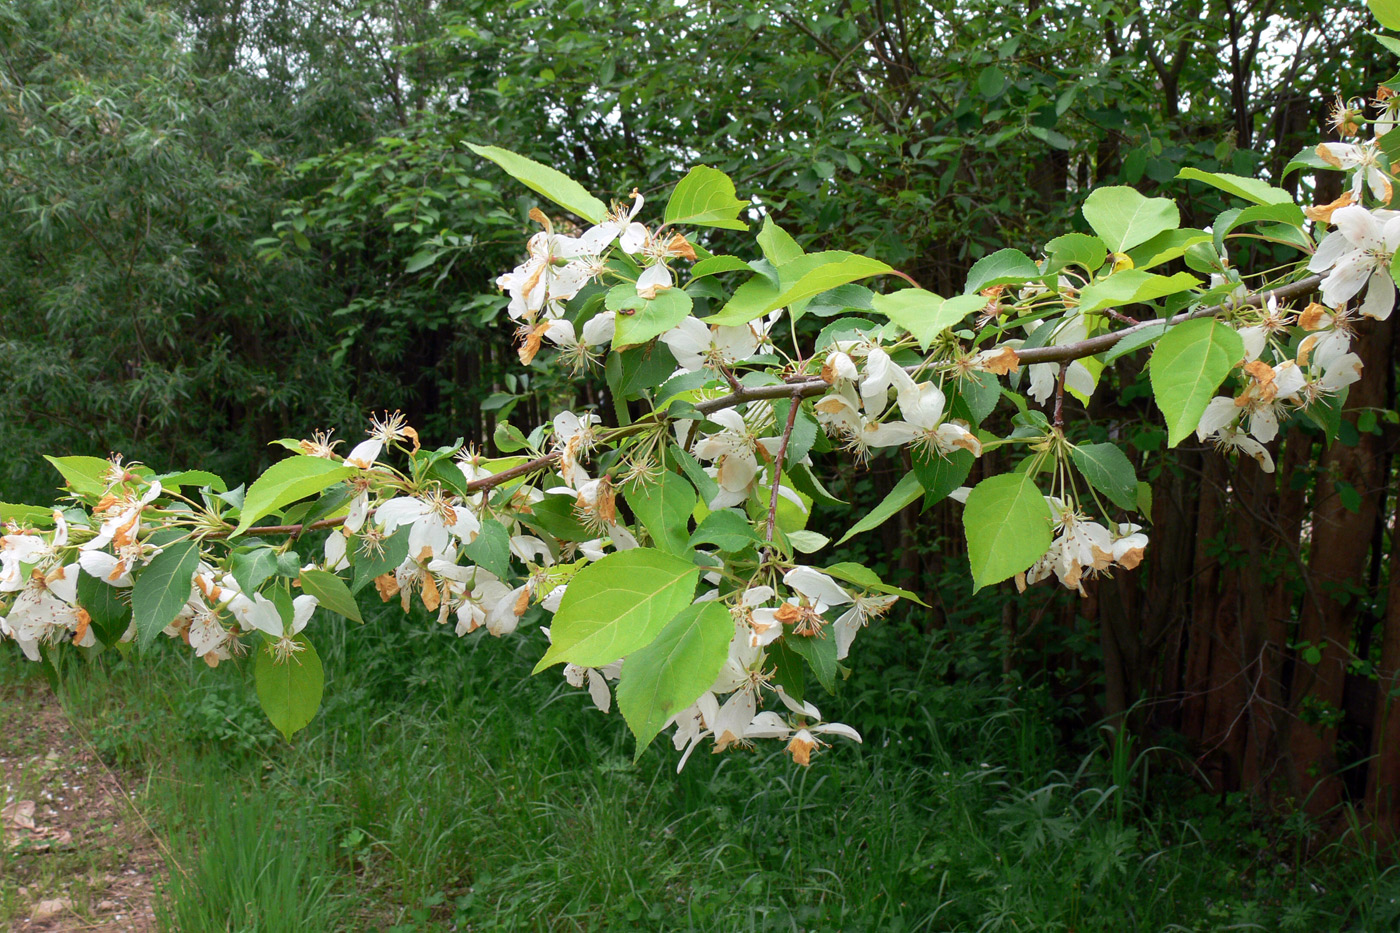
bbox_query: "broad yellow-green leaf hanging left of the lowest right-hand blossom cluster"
[963,474,1053,590]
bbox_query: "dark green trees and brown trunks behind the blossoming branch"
[0,0,1400,913]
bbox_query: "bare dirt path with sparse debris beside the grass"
[0,678,164,933]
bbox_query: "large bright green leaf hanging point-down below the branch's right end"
[1148,318,1245,447]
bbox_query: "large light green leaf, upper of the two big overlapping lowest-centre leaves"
[535,548,700,672]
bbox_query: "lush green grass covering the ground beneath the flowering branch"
[13,602,1400,933]
